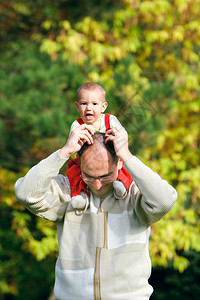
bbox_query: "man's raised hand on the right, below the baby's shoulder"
[105,127,132,163]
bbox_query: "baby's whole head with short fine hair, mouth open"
[75,82,107,124]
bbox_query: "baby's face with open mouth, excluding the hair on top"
[76,89,107,125]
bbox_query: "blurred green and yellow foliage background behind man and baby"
[0,0,200,300]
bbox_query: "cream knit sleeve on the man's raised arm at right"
[125,156,177,226]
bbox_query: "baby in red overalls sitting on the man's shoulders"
[67,82,133,214]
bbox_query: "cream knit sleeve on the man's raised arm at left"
[15,151,70,222]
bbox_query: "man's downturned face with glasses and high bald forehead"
[80,145,121,197]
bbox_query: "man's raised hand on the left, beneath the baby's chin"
[59,124,94,158]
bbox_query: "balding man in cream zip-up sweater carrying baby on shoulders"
[15,124,177,300]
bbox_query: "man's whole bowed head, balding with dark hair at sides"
[78,133,122,197]
